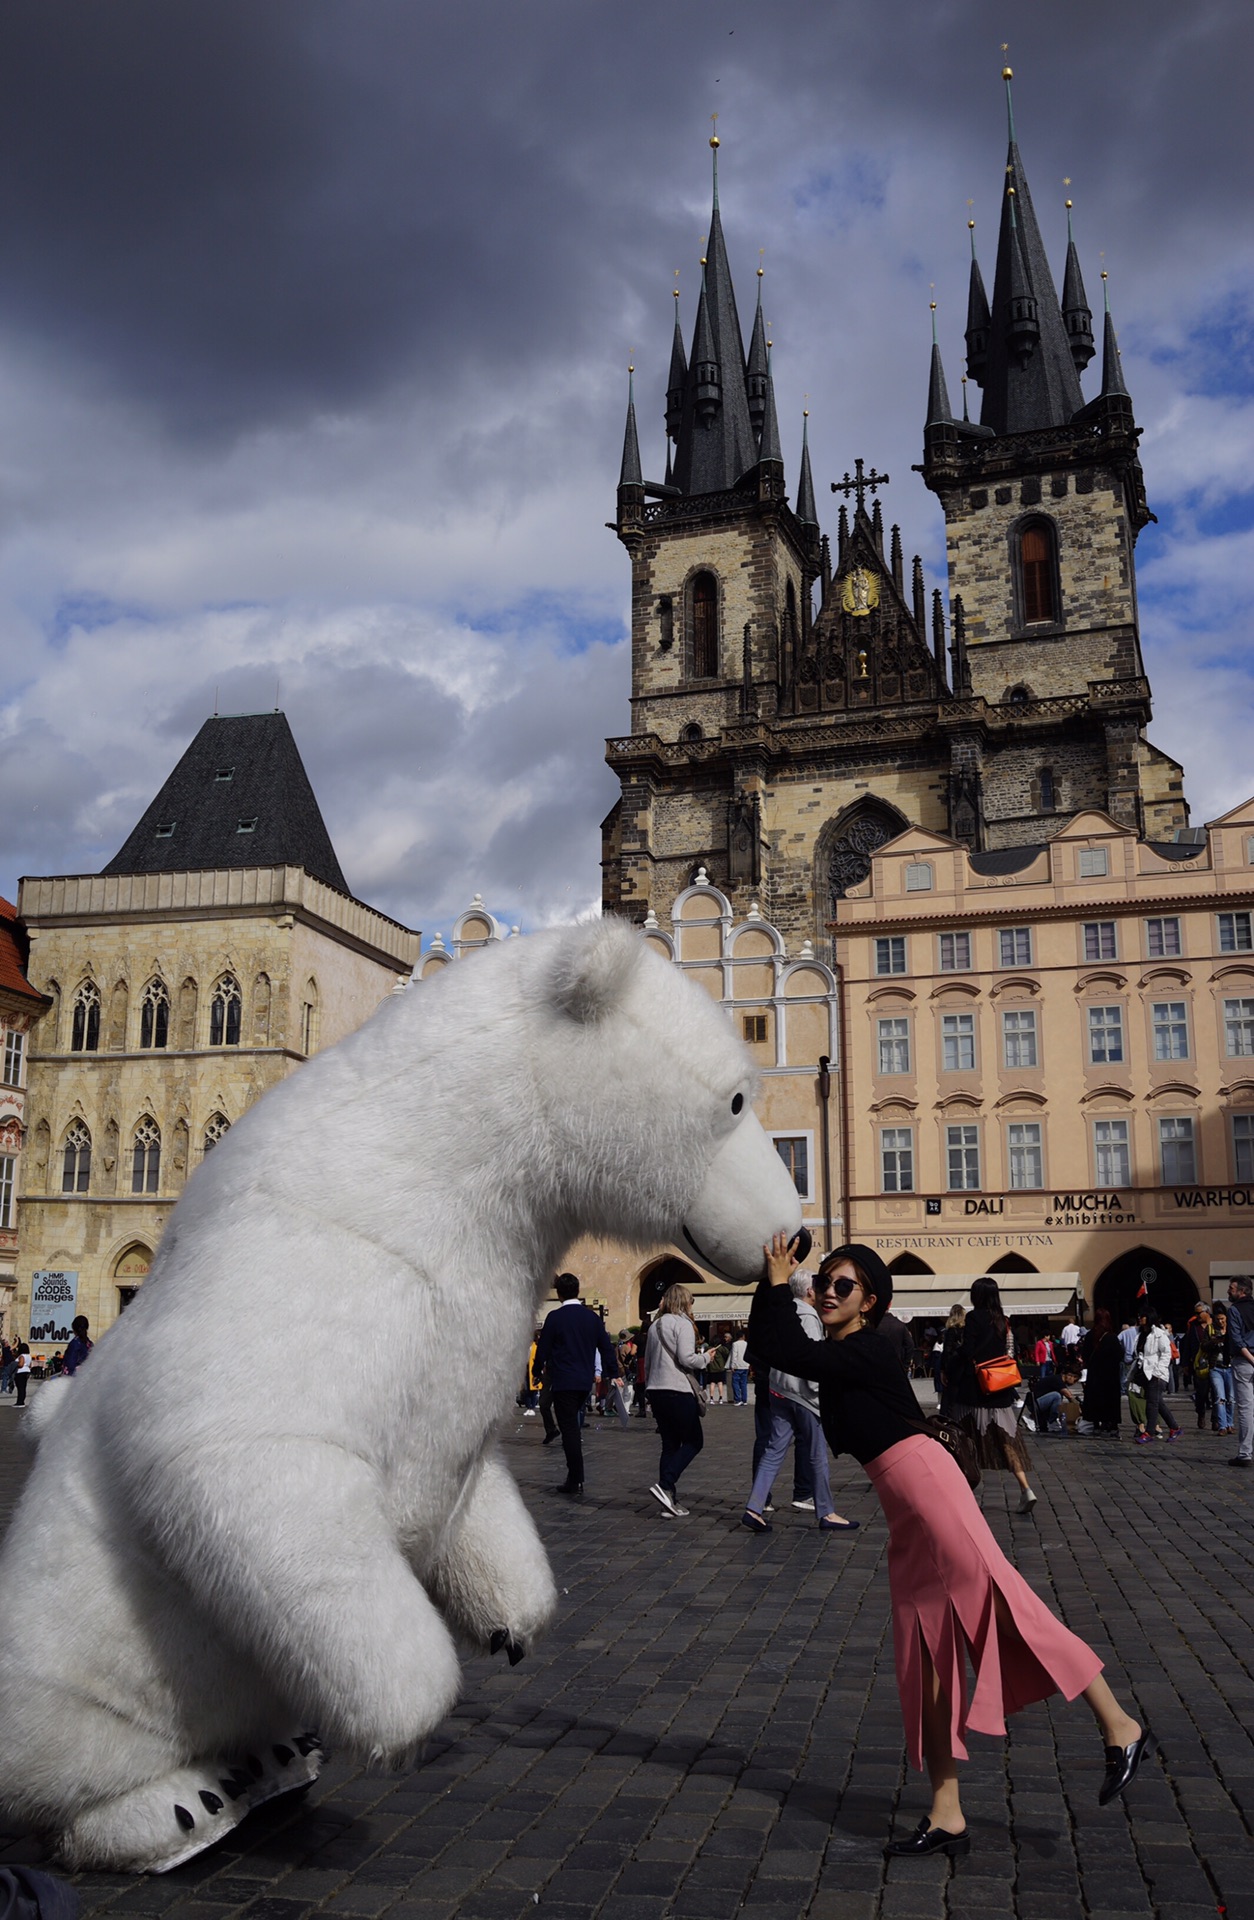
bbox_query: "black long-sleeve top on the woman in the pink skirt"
[749,1281,924,1467]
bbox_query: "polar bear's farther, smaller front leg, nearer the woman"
[426,1455,557,1663]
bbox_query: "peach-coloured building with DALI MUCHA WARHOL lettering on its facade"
[833,801,1254,1327]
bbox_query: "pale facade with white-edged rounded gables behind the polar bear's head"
[409,874,843,1332]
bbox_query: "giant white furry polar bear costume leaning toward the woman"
[0,920,801,1870]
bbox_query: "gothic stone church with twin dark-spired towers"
[603,69,1189,952]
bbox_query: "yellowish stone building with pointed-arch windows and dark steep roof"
[15,714,421,1352]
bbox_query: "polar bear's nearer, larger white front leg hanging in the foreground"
[167,1440,461,1763]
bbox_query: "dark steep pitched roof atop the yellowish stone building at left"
[102,712,350,893]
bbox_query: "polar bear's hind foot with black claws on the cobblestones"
[56,1732,326,1874]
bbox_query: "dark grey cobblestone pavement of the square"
[0,1400,1254,1920]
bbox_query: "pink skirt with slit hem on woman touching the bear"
[866,1434,1102,1770]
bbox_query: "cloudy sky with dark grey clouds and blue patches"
[0,0,1254,935]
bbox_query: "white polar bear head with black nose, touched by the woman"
[506,918,801,1284]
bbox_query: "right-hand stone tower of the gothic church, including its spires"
[918,67,1189,847]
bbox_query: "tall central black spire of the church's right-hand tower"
[979,67,1083,434]
